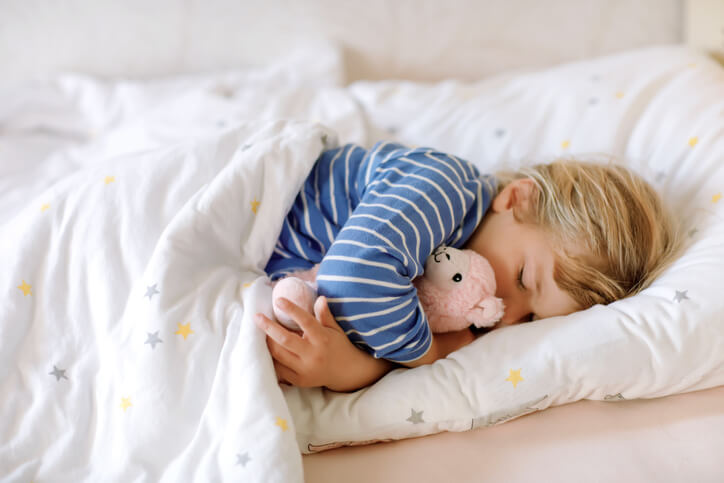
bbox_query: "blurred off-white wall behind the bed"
[0,0,682,85]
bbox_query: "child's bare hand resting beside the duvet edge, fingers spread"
[254,297,382,391]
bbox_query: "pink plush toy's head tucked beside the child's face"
[414,246,504,332]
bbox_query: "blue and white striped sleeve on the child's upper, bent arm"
[317,144,492,362]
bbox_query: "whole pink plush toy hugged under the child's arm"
[272,246,505,333]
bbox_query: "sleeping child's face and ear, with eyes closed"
[465,179,578,327]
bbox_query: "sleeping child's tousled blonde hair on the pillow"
[497,160,680,309]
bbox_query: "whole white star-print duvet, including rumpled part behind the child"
[0,45,362,483]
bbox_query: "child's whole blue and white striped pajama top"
[265,142,496,362]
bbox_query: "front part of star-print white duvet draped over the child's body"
[0,114,334,482]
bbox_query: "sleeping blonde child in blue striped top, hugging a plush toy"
[255,142,677,391]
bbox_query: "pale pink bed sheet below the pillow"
[304,387,724,483]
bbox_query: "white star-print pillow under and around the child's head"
[285,47,724,452]
